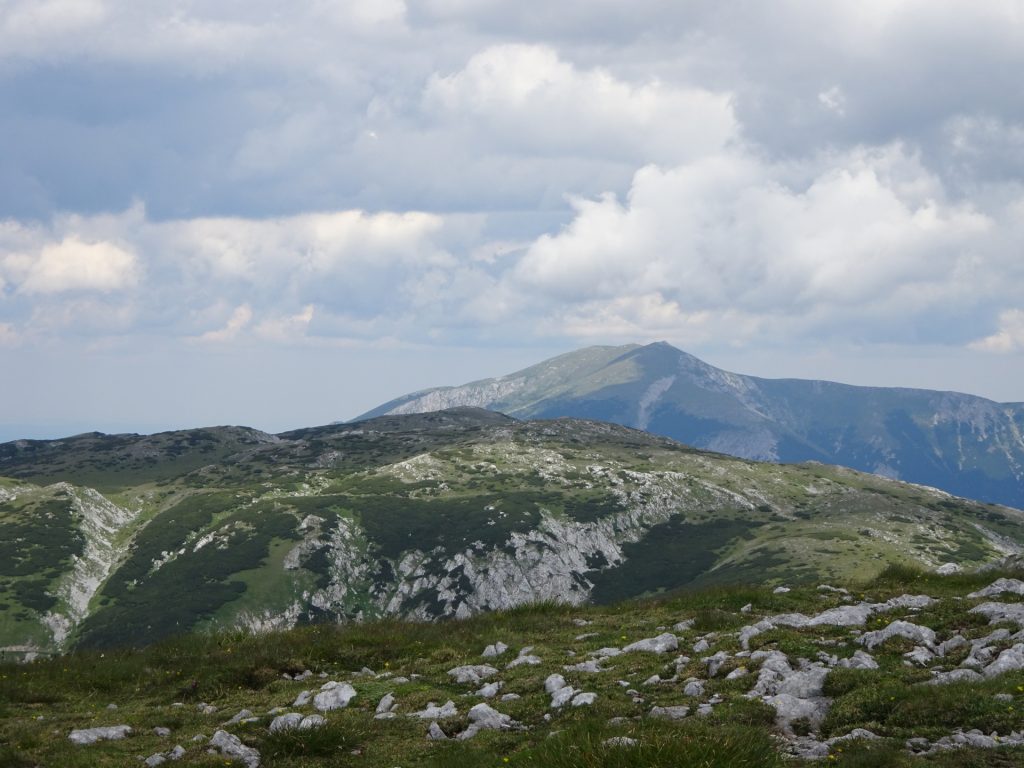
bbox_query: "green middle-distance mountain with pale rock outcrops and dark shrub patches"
[0,408,1024,653]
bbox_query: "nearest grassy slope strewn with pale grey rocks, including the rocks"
[6,559,1024,768]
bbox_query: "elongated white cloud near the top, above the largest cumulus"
[424,44,737,162]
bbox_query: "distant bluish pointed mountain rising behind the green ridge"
[359,342,1024,507]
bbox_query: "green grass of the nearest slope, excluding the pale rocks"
[0,568,1024,768]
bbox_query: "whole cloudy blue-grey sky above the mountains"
[0,0,1024,440]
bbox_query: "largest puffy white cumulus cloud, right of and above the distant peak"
[513,145,996,339]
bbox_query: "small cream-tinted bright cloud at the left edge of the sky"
[2,236,139,295]
